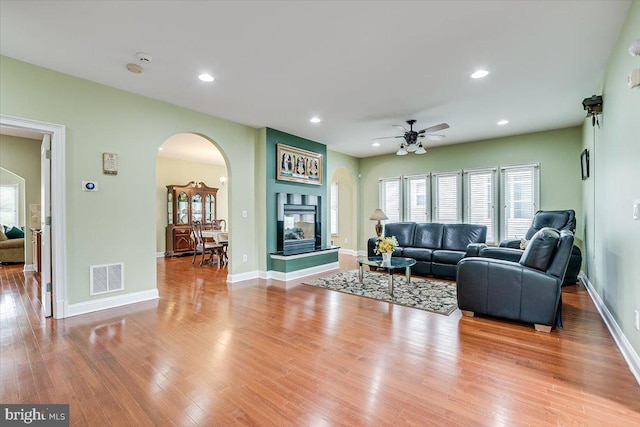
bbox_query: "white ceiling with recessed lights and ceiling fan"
[0,0,631,157]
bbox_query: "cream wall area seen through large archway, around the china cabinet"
[156,133,229,257]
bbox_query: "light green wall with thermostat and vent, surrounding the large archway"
[0,56,264,304]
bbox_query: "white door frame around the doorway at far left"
[0,114,67,319]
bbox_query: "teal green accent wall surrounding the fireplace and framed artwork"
[263,128,324,270]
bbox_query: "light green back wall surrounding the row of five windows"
[359,127,583,250]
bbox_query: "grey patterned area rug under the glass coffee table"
[303,270,458,316]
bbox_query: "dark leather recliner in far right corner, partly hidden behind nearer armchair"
[480,209,582,285]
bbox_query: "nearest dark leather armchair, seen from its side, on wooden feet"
[456,228,573,332]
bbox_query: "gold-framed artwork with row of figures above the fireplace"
[276,144,323,185]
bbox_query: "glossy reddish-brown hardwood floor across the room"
[0,257,640,426]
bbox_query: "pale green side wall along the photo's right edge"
[581,1,640,354]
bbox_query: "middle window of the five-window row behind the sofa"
[432,171,462,224]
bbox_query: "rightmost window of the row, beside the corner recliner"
[501,164,540,239]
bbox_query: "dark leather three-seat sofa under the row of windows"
[367,222,487,279]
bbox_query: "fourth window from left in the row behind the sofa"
[464,168,498,244]
